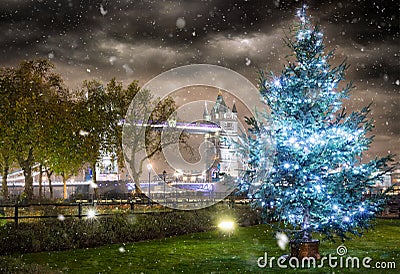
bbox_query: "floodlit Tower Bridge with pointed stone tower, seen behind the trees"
[0,92,242,199]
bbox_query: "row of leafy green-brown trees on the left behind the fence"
[0,59,176,201]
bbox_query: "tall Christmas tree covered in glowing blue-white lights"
[241,7,391,241]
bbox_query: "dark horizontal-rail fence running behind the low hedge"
[0,194,243,227]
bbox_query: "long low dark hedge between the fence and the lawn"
[0,204,260,255]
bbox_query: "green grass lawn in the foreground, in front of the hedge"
[8,219,400,273]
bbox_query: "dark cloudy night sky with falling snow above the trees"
[0,0,400,162]
